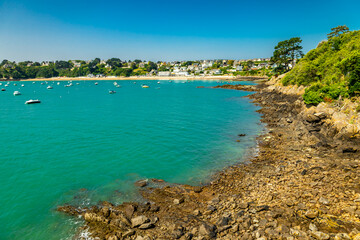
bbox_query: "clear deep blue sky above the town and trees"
[0,0,360,61]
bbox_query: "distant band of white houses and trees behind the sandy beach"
[0,58,284,80]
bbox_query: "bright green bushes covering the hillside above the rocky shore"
[282,26,360,105]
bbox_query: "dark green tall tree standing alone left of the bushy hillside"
[271,37,304,71]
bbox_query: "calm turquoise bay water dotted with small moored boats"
[0,81,262,240]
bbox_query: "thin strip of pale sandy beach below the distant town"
[16,76,266,82]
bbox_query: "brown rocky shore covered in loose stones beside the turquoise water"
[58,84,360,240]
